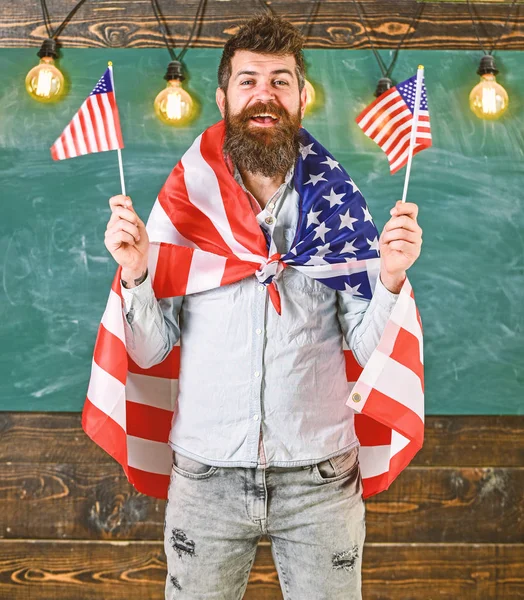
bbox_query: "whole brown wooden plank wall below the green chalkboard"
[0,412,524,600]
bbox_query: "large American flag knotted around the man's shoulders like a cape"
[82,121,424,498]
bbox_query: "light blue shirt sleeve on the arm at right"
[337,276,399,367]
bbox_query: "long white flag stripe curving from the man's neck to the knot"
[181,135,266,264]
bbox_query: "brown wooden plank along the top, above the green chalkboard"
[0,0,524,50]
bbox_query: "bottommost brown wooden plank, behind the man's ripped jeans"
[0,540,524,600]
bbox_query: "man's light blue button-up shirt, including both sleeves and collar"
[122,163,398,468]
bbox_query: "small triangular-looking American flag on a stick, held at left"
[51,66,124,160]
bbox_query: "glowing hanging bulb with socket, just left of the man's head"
[155,60,193,126]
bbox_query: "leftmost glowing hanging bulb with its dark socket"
[25,38,64,102]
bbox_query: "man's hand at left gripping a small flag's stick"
[105,194,149,287]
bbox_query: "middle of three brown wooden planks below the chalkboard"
[0,463,524,543]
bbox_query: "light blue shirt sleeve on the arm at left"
[120,273,184,369]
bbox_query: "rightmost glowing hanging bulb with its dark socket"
[469,54,509,120]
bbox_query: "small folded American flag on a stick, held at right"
[355,75,431,175]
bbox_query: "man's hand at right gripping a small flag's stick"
[379,200,422,294]
